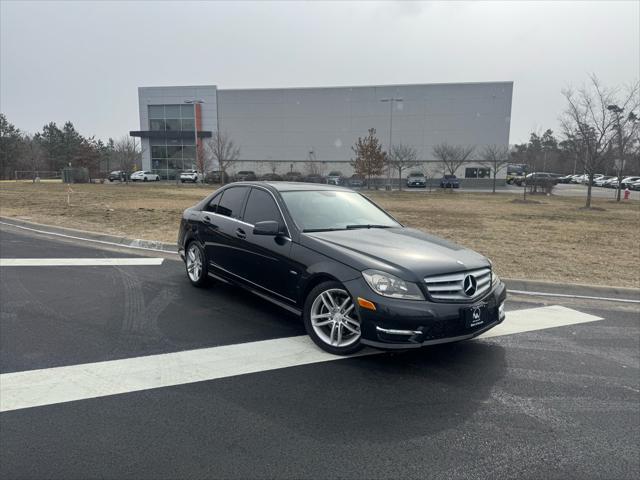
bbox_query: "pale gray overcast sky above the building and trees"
[0,0,640,143]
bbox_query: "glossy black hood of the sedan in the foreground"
[300,227,491,281]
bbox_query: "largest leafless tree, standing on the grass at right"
[561,75,616,208]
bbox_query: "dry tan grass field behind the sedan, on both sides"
[0,182,640,287]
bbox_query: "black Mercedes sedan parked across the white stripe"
[178,182,506,355]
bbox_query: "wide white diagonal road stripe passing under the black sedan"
[0,306,602,412]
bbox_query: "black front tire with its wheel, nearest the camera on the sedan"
[302,281,363,355]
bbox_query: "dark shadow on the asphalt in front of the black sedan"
[217,341,506,443]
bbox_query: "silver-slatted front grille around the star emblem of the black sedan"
[424,268,491,302]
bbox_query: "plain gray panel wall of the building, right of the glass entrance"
[218,82,513,173]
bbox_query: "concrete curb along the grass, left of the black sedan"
[0,217,178,254]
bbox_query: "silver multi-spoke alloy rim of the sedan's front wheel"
[310,288,360,348]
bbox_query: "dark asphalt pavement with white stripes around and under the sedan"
[0,225,640,478]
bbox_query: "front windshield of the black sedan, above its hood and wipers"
[281,190,400,231]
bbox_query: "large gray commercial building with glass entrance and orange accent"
[131,82,513,183]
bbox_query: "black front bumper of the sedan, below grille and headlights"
[345,278,507,349]
